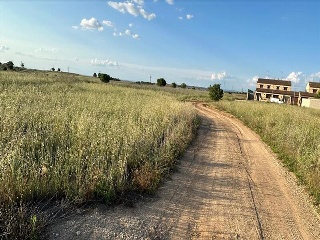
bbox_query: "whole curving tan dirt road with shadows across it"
[49,104,320,239]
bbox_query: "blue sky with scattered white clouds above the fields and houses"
[0,0,320,90]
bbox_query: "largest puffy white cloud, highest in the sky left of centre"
[108,0,156,20]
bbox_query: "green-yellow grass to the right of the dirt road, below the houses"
[214,101,320,205]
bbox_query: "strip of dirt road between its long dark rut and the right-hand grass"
[197,104,320,239]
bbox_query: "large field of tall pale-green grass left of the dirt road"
[0,71,198,239]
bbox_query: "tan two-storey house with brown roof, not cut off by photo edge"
[254,78,299,104]
